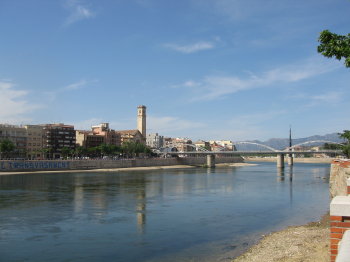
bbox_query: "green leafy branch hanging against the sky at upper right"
[317,30,350,67]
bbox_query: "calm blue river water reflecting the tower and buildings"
[0,163,330,262]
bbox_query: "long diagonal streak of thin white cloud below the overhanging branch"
[177,58,339,101]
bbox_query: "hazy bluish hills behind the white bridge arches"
[236,133,344,151]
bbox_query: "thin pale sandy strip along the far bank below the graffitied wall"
[0,163,256,176]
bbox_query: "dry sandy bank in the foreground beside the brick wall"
[233,215,330,262]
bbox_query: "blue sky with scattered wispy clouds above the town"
[0,0,350,141]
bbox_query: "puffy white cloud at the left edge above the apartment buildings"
[0,80,42,124]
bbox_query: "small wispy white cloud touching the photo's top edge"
[64,0,96,26]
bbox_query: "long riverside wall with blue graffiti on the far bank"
[0,156,243,172]
